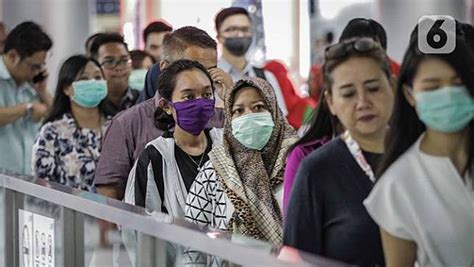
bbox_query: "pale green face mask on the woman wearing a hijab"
[232,111,275,150]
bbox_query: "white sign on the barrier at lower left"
[18,210,55,267]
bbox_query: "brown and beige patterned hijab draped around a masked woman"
[209,77,297,244]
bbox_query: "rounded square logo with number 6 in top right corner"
[418,15,456,54]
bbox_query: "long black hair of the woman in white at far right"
[376,33,474,180]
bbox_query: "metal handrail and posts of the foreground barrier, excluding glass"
[0,172,339,266]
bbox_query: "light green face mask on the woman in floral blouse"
[71,80,107,108]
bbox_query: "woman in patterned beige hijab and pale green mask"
[185,77,297,245]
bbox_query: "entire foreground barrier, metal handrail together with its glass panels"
[0,172,348,267]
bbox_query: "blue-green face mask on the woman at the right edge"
[414,85,474,133]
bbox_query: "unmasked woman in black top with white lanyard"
[284,38,394,266]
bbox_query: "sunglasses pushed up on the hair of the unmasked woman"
[324,38,380,60]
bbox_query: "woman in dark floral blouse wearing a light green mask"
[32,55,107,191]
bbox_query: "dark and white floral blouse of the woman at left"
[32,113,108,191]
